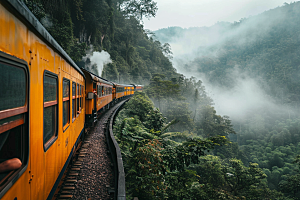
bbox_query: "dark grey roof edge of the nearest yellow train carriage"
[1,0,85,78]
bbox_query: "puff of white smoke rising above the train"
[82,50,112,76]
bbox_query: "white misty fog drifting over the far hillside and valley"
[155,3,300,122]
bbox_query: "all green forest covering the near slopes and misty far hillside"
[22,0,300,199]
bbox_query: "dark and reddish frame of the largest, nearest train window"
[0,51,30,199]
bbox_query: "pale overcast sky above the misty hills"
[144,0,294,31]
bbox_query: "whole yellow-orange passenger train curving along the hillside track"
[0,0,143,200]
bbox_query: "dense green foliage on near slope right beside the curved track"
[114,93,283,200]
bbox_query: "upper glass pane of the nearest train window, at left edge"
[0,62,26,111]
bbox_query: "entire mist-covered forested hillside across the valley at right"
[155,2,300,195]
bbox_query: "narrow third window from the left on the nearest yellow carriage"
[63,78,70,129]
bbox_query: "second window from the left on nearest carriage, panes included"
[44,72,58,151]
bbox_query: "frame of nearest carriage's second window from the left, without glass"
[43,70,59,152]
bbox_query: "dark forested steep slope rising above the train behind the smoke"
[23,0,178,84]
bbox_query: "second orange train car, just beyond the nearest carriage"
[82,69,113,126]
